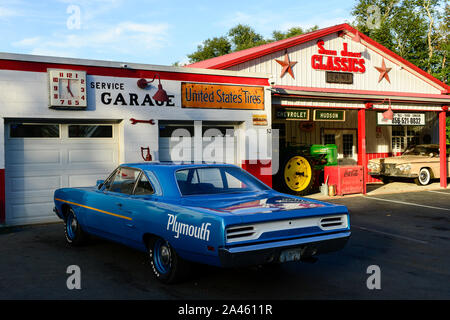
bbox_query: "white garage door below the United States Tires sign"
[159,124,237,164]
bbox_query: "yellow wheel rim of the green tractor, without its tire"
[284,156,312,192]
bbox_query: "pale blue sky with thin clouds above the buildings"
[0,0,355,65]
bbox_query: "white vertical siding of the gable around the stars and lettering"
[229,34,441,94]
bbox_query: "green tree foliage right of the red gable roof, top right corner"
[351,0,450,82]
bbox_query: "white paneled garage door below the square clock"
[5,122,119,225]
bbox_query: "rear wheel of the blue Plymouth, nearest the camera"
[147,237,190,284]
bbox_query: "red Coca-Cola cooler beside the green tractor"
[324,166,364,196]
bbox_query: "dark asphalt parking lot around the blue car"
[0,189,450,300]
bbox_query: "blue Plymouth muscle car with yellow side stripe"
[54,162,350,283]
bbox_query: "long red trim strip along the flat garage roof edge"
[0,60,269,86]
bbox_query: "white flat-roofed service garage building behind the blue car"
[0,53,271,225]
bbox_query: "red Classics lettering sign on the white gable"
[311,40,366,73]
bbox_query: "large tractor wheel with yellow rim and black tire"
[280,154,318,196]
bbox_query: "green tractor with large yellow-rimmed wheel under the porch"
[274,144,338,196]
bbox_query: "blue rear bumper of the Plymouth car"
[219,231,351,267]
